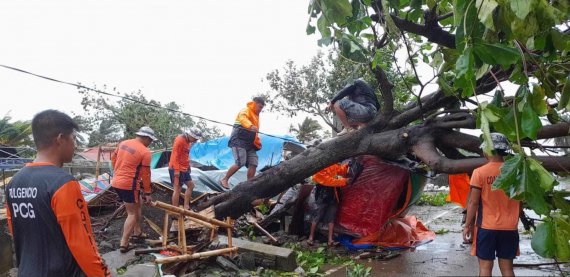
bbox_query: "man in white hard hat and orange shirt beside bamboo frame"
[111,126,156,253]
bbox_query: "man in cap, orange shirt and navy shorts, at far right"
[463,133,520,276]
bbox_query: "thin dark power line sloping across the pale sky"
[0,64,305,145]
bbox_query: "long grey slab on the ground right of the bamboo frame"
[218,235,297,271]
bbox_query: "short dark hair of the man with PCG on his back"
[32,110,79,149]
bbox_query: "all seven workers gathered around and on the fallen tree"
[5,80,520,276]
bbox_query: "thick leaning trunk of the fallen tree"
[199,123,570,218]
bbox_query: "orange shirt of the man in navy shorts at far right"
[471,162,520,230]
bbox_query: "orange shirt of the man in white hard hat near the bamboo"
[111,139,151,193]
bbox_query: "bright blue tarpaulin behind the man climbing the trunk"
[190,134,297,170]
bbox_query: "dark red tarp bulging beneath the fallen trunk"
[337,156,410,236]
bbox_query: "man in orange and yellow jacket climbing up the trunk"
[220,97,265,189]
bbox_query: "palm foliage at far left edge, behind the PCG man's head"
[0,115,33,147]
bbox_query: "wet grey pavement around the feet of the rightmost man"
[330,204,570,276]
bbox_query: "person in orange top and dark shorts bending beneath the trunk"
[307,164,350,246]
